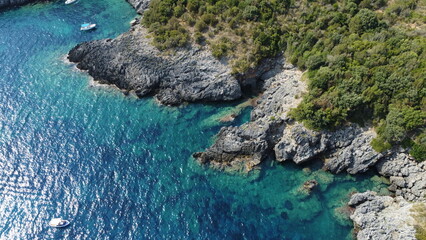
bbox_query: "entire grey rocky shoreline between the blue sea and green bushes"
[69,0,426,239]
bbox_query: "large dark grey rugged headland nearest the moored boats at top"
[68,26,242,105]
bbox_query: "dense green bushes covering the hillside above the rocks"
[143,0,426,161]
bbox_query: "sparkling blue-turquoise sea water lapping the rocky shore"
[0,0,385,239]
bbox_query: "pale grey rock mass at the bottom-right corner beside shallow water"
[349,192,416,240]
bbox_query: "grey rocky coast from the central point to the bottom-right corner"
[194,57,426,237]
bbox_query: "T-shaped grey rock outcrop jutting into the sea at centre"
[194,58,383,174]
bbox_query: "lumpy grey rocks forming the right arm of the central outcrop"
[274,123,382,174]
